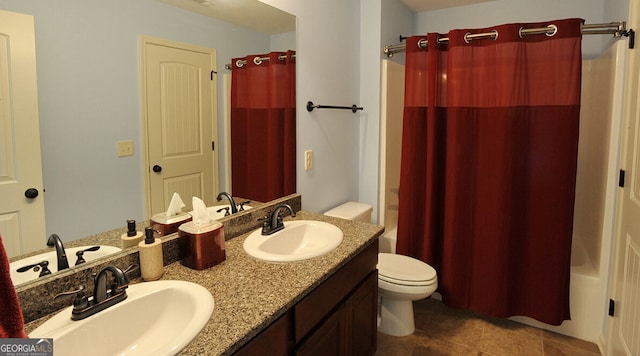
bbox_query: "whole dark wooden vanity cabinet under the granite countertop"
[236,240,378,356]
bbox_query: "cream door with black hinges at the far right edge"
[606,0,640,356]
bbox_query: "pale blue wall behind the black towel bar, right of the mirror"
[261,0,362,212]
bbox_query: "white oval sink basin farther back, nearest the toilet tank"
[243,220,343,262]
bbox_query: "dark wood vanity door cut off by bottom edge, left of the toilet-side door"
[296,305,347,356]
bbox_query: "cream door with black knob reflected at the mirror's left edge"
[0,10,46,257]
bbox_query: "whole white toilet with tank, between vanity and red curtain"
[325,202,438,336]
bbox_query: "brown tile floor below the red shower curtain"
[375,299,600,356]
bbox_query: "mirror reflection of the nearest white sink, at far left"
[9,245,122,285]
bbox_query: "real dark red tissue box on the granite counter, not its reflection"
[178,220,227,270]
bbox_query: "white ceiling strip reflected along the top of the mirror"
[158,0,296,35]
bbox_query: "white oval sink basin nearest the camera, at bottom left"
[29,281,214,355]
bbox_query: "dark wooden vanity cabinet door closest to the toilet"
[345,270,378,356]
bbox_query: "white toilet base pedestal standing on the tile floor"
[378,297,416,336]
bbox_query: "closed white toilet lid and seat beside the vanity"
[378,253,436,285]
